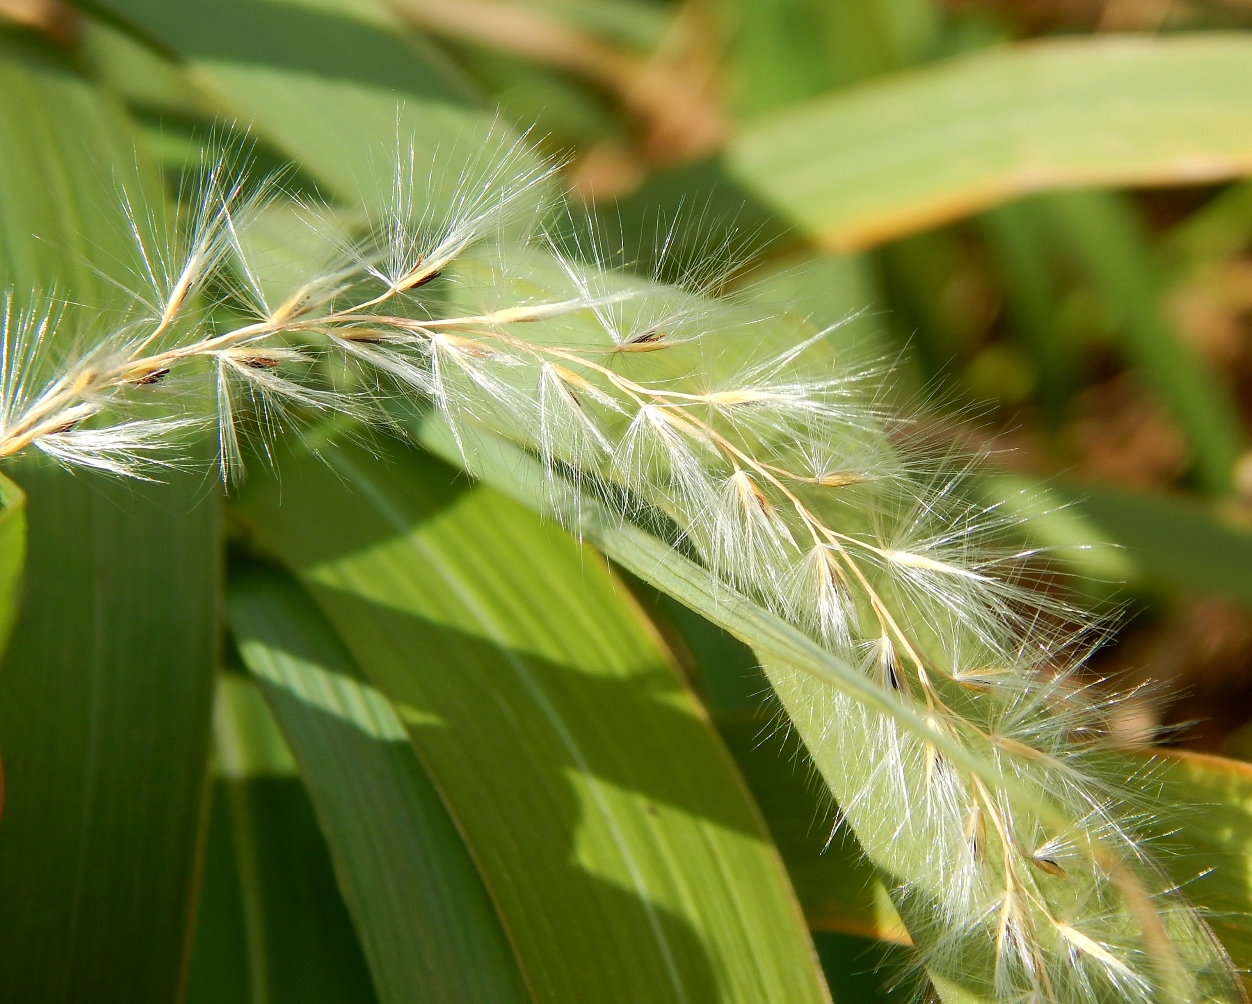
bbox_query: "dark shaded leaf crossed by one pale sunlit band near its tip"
[229,568,530,1004]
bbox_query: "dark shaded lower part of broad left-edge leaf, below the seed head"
[0,463,217,1001]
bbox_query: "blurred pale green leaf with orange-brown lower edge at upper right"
[729,34,1252,250]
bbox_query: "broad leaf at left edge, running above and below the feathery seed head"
[0,40,218,1004]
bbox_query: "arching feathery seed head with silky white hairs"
[0,142,1242,1001]
